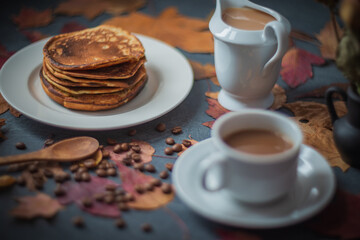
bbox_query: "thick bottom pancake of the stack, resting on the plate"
[40,69,147,111]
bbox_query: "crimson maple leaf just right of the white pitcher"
[280,47,325,88]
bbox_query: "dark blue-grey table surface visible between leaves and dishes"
[0,0,360,240]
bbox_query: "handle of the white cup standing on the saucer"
[199,153,226,192]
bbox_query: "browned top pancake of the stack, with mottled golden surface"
[43,25,145,70]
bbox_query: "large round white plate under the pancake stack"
[0,35,193,130]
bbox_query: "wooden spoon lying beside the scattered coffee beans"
[0,137,99,166]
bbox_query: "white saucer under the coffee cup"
[172,139,335,228]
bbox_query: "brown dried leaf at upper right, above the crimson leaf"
[315,21,343,60]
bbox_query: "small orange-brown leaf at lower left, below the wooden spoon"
[10,193,63,219]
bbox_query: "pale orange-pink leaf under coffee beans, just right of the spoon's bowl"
[105,140,155,163]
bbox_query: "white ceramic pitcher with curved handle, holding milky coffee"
[209,0,290,111]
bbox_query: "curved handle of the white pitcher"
[262,21,289,75]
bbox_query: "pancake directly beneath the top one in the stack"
[45,57,146,79]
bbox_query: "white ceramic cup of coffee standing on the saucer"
[199,109,302,204]
